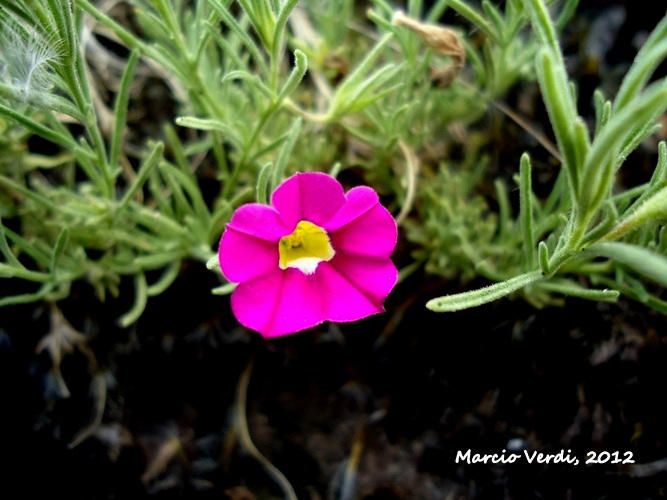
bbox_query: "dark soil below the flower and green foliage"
[0,268,667,499]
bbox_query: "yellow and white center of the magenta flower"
[278,220,336,274]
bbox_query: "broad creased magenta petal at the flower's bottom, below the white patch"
[232,269,326,338]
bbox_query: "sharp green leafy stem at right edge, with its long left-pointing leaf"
[427,0,667,312]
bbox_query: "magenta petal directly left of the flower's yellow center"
[218,226,280,283]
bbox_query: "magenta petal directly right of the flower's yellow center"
[329,203,398,258]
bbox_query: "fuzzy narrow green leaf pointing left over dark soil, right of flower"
[426,271,542,312]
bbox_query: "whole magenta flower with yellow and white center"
[218,173,397,337]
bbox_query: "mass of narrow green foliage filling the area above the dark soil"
[0,0,667,325]
